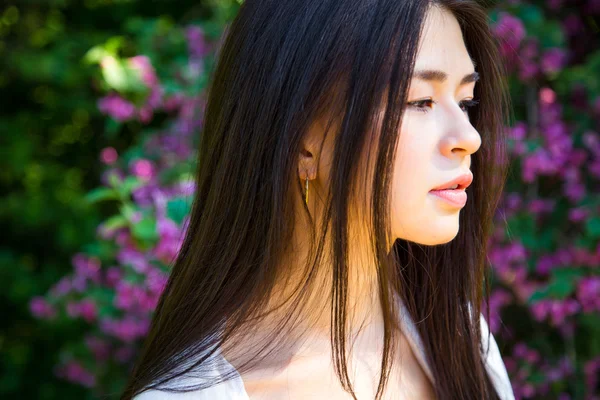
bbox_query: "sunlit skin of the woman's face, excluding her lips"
[391,7,481,245]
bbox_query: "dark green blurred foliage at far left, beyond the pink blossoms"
[0,0,237,400]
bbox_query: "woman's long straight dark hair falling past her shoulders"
[122,0,510,399]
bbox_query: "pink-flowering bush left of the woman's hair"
[30,13,227,395]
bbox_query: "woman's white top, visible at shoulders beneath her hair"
[133,301,515,400]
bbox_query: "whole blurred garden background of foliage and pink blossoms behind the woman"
[0,0,600,400]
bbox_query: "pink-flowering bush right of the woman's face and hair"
[489,0,600,399]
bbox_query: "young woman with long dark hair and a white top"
[122,0,514,400]
